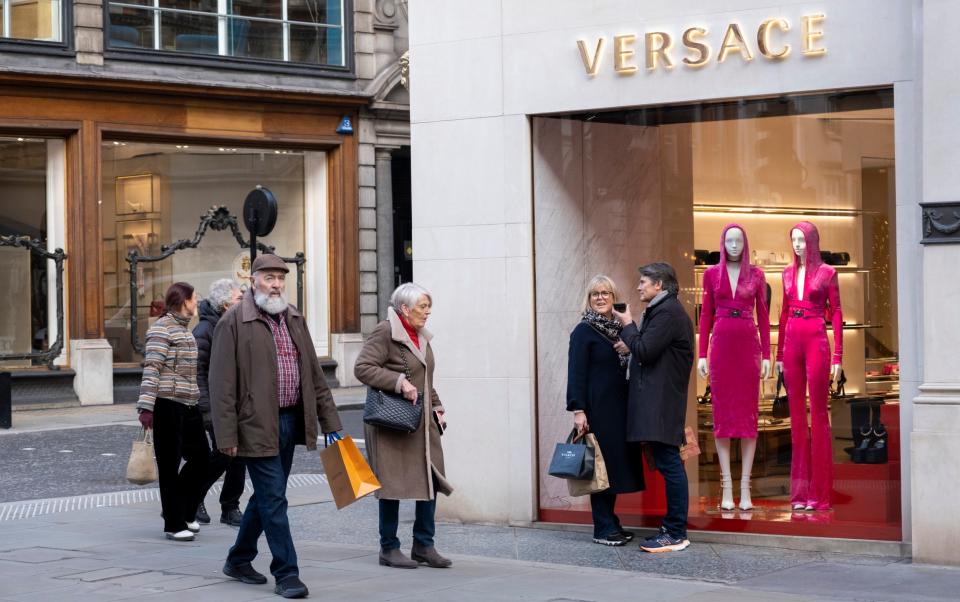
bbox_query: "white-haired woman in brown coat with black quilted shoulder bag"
[354,282,453,569]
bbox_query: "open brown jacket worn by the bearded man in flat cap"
[209,290,343,457]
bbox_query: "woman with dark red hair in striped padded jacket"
[137,282,210,541]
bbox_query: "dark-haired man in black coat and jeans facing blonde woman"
[614,263,694,552]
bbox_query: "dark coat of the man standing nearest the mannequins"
[620,294,694,442]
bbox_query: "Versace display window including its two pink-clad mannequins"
[532,89,901,540]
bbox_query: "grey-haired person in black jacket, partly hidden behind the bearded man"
[193,278,246,527]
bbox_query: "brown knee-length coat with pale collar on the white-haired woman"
[354,307,453,500]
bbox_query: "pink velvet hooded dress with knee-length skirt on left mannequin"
[700,224,770,439]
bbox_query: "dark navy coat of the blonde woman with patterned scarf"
[567,322,644,493]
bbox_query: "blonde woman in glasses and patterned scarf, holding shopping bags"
[567,275,644,546]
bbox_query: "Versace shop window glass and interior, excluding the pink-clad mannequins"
[533,89,901,540]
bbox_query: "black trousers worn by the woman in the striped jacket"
[153,397,210,533]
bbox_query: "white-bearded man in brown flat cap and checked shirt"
[209,254,342,598]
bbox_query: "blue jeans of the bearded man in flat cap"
[227,412,300,582]
